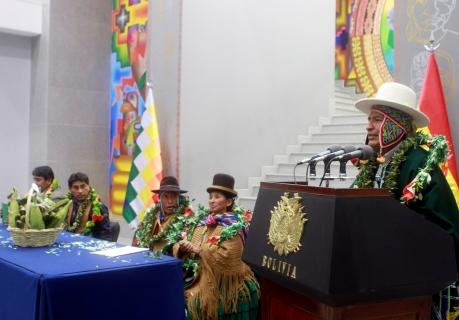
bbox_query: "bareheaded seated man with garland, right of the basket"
[65,172,110,240]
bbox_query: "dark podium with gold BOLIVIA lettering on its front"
[243,183,456,320]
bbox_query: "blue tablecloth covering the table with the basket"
[0,225,184,320]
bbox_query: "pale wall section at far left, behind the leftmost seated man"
[0,33,32,201]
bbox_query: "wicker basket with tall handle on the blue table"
[8,189,62,247]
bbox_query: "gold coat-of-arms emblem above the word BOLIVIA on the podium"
[268,192,308,256]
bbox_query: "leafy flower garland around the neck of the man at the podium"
[354,132,448,204]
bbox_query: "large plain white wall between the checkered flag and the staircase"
[179,0,335,202]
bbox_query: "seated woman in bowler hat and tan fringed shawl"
[173,174,259,319]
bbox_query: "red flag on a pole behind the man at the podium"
[419,52,459,202]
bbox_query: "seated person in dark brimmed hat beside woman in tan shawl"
[132,176,193,253]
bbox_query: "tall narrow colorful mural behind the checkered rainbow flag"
[109,0,148,214]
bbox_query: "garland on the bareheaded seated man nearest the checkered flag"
[65,188,104,235]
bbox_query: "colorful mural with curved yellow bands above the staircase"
[335,0,394,96]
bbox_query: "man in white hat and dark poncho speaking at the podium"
[353,82,459,319]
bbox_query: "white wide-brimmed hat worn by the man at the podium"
[355,82,429,128]
